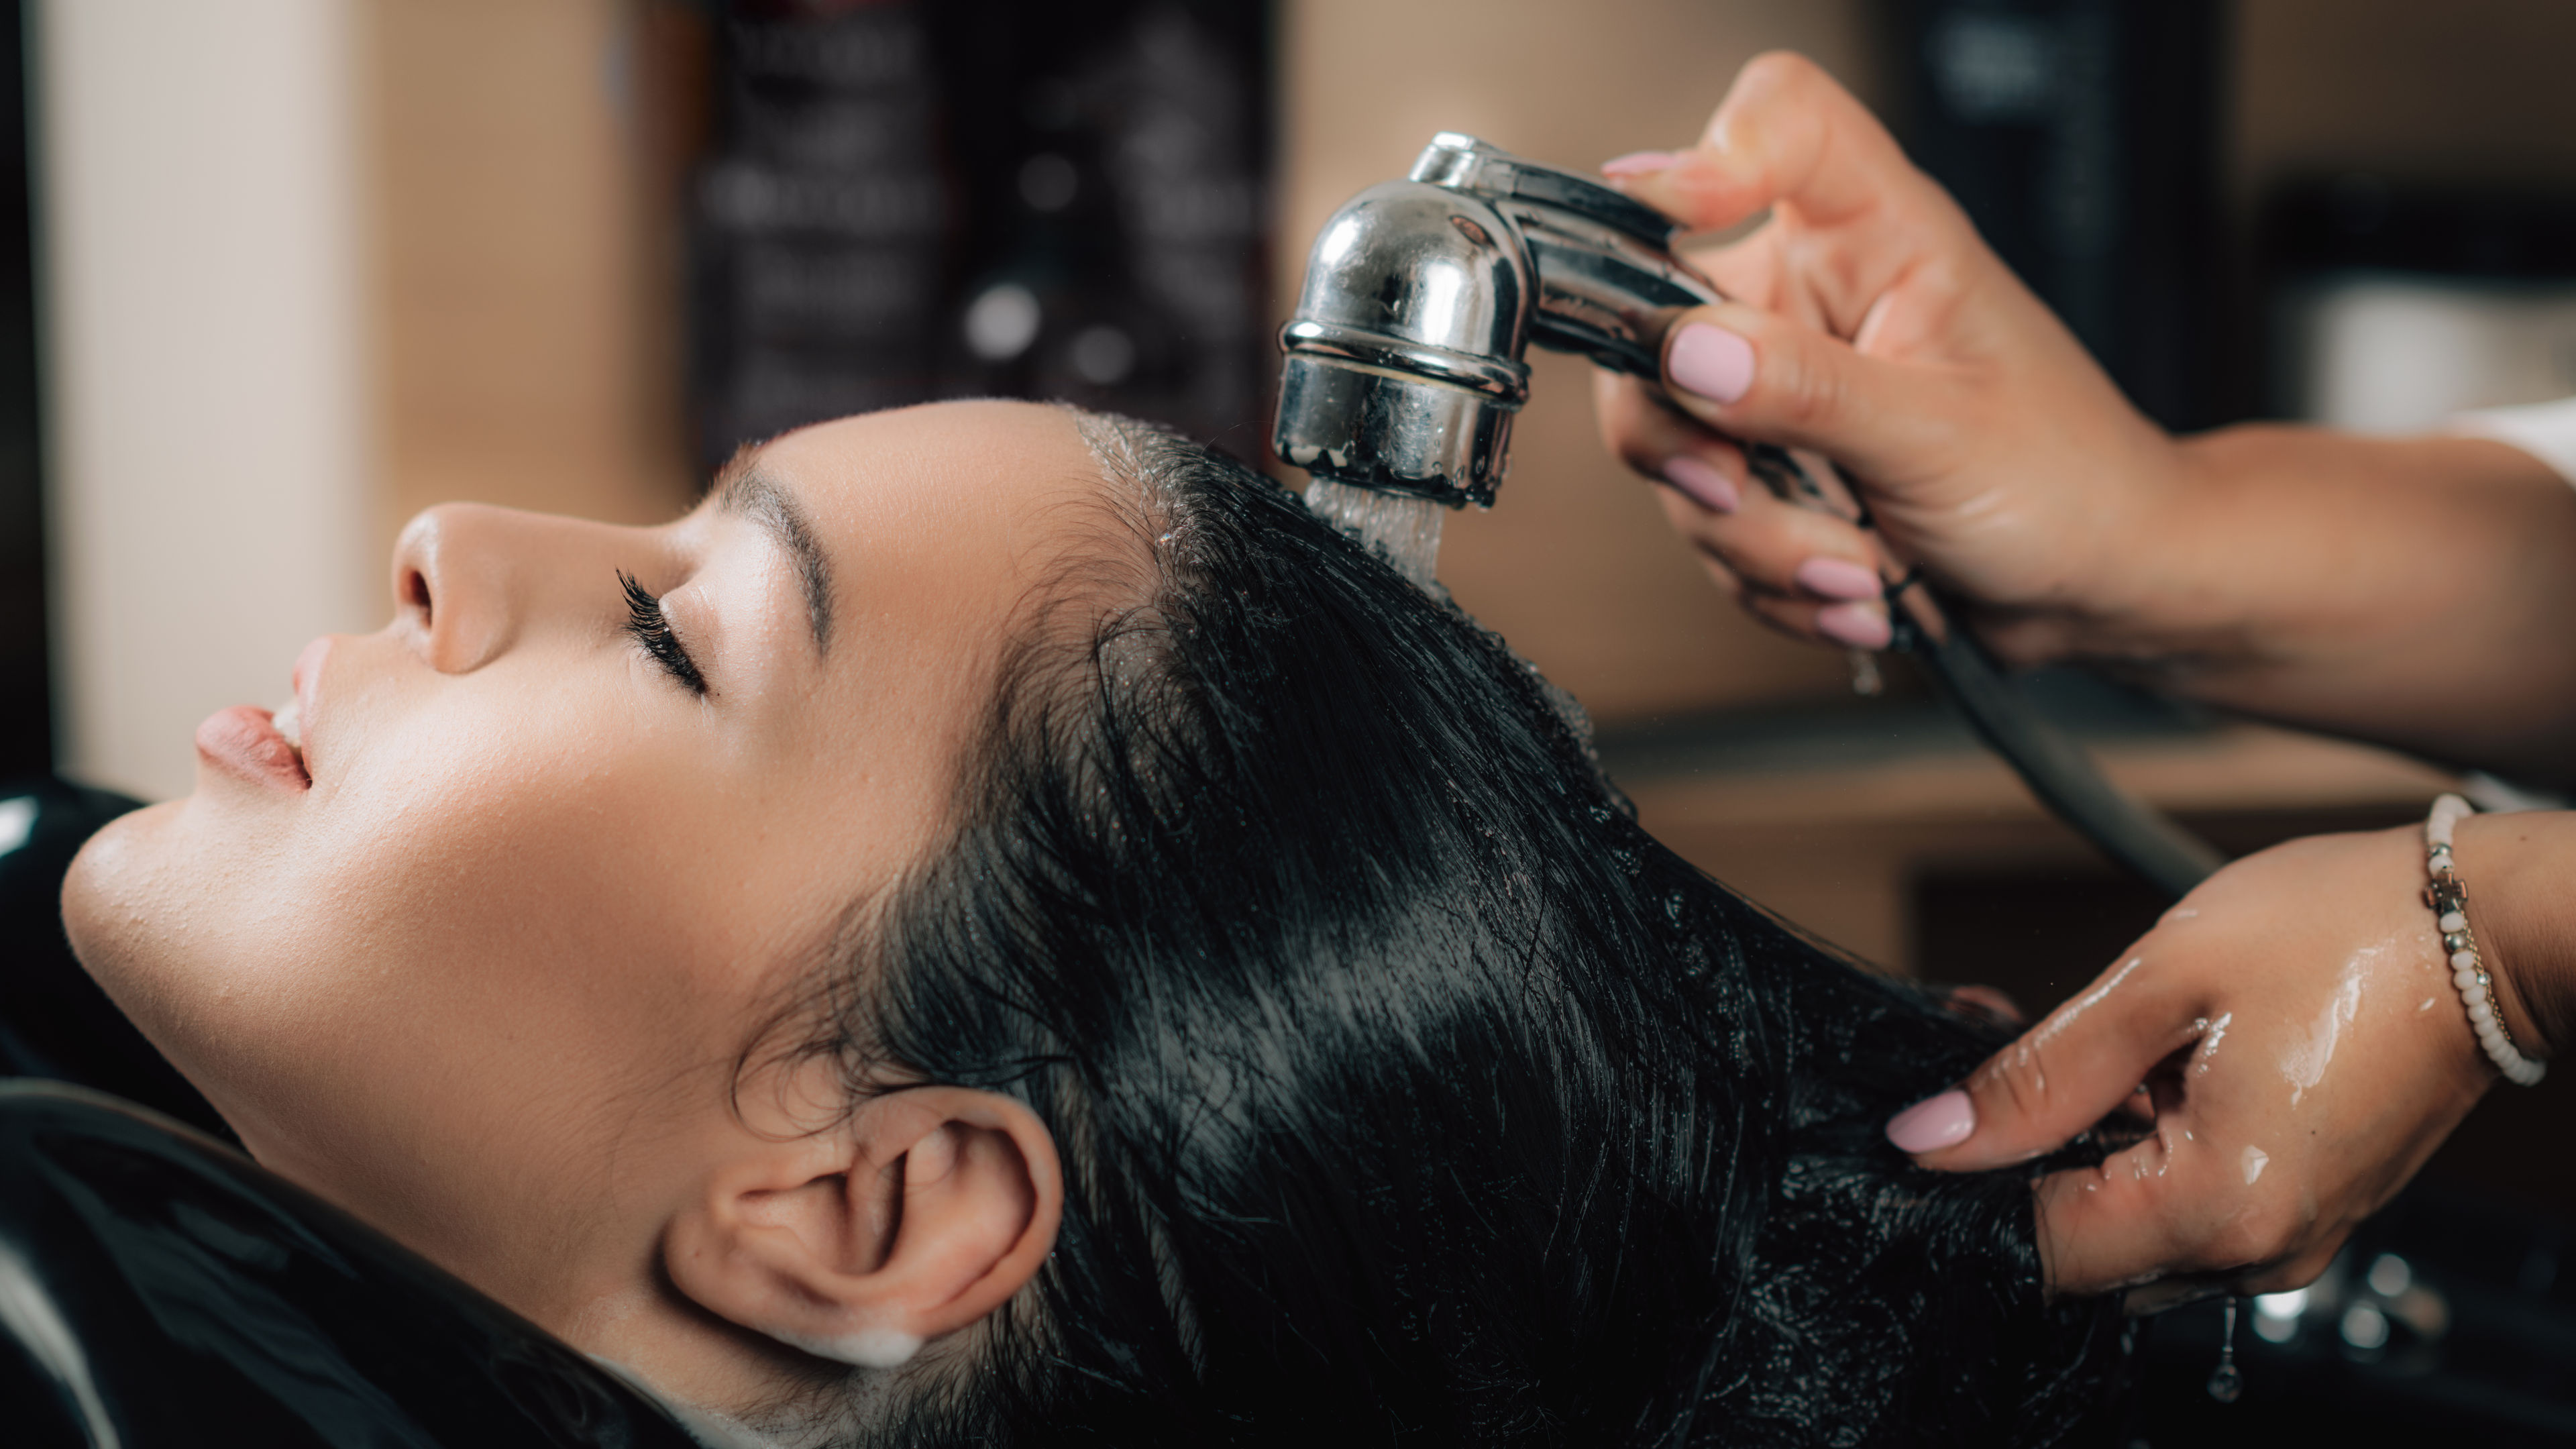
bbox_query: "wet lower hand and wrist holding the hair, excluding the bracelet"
[1888,815,2576,1309]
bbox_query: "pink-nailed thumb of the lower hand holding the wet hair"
[1888,957,2200,1173]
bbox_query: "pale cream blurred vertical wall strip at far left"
[31,0,384,797]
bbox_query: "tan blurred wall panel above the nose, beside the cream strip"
[361,0,693,541]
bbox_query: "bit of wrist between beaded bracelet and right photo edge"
[2453,810,2576,1060]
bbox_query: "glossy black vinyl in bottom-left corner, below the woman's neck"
[0,1080,693,1449]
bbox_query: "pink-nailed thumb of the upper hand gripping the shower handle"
[1664,302,1971,482]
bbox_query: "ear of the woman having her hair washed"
[662,1085,1064,1369]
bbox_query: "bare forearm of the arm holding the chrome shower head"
[2074,428,2576,784]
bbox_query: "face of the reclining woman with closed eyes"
[64,402,1103,1312]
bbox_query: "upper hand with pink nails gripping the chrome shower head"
[1600,54,2182,663]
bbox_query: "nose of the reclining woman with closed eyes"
[394,502,616,673]
